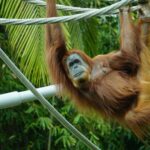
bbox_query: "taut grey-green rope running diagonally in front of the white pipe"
[0,48,100,150]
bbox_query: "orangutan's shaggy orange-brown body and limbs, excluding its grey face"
[46,0,150,137]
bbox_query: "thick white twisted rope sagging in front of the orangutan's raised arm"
[0,0,133,25]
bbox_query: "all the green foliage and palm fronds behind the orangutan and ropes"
[0,0,149,150]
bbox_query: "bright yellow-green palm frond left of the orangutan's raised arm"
[0,0,48,85]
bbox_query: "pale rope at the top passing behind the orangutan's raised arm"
[25,0,140,14]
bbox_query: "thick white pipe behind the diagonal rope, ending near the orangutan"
[0,85,58,109]
